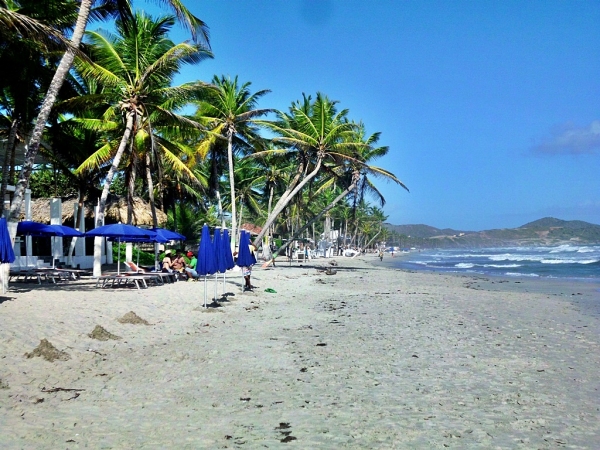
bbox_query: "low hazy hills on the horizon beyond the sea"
[385,217,600,247]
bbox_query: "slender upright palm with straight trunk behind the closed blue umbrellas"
[194,76,271,248]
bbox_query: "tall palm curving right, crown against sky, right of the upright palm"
[254,92,363,248]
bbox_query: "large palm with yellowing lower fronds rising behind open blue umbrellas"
[72,13,210,274]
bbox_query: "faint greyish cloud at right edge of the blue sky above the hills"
[532,120,600,155]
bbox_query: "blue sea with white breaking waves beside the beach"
[386,245,600,280]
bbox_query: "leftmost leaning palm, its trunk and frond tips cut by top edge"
[5,0,208,241]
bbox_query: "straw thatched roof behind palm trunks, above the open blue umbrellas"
[21,197,167,226]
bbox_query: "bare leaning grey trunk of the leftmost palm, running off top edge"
[8,0,92,243]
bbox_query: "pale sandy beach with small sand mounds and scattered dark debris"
[0,256,600,449]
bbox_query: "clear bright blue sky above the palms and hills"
[139,0,600,230]
